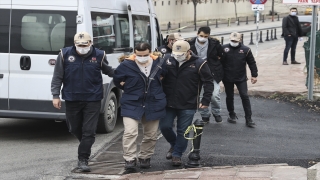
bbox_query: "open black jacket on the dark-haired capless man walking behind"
[189,38,223,83]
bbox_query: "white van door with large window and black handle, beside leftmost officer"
[9,0,77,112]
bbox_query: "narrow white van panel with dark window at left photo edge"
[0,0,11,110]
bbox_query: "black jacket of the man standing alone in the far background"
[282,15,302,37]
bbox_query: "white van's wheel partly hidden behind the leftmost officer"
[97,92,118,133]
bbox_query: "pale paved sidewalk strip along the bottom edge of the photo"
[118,164,307,180]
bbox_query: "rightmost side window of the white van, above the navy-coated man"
[132,15,151,45]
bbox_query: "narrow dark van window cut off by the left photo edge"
[0,9,10,53]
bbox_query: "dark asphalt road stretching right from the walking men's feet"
[141,93,320,171]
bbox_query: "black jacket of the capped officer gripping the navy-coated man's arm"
[163,56,214,109]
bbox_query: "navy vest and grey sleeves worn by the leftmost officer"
[51,46,113,101]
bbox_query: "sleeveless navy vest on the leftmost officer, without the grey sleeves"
[61,46,105,101]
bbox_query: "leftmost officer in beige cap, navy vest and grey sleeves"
[51,32,113,172]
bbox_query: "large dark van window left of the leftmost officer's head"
[10,10,77,54]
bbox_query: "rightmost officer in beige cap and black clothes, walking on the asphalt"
[221,32,258,128]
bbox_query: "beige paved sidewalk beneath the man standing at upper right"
[247,38,307,97]
